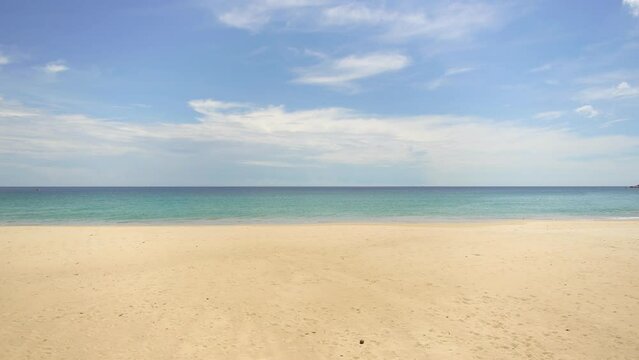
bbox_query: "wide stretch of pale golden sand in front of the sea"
[0,221,639,360]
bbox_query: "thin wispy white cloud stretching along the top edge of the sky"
[217,0,501,40]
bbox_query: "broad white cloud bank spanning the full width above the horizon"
[0,99,639,184]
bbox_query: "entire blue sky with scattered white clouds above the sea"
[0,0,639,186]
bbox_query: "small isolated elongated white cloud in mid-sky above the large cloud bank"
[293,53,410,87]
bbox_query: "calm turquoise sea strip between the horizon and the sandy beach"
[0,187,639,225]
